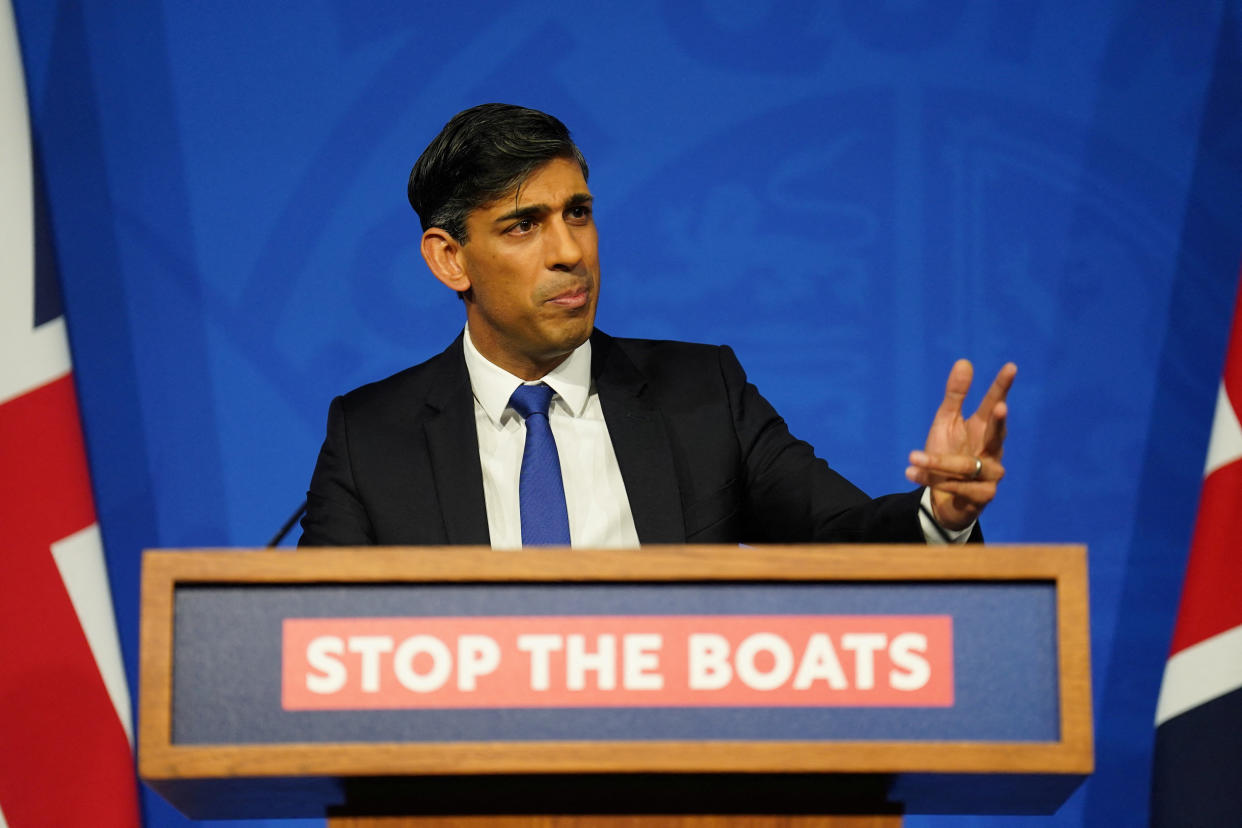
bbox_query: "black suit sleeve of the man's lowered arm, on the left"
[298,397,375,546]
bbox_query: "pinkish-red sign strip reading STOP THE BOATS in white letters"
[281,614,954,710]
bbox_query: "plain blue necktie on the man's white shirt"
[509,382,569,546]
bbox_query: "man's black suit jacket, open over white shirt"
[301,331,938,546]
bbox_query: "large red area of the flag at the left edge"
[0,375,138,828]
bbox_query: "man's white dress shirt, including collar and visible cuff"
[463,325,974,549]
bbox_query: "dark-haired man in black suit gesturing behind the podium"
[301,104,1017,547]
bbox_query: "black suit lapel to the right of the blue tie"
[591,330,686,544]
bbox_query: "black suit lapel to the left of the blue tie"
[424,336,491,546]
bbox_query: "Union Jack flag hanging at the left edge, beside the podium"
[0,0,139,828]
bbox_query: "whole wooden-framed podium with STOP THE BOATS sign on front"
[139,546,1093,828]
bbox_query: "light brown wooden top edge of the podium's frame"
[143,544,1087,583]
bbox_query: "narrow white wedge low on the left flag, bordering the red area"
[50,524,134,744]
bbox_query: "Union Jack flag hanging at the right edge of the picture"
[1151,269,1242,828]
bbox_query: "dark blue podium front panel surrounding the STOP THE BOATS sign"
[173,582,1059,745]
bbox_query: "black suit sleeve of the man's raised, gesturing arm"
[720,346,925,544]
